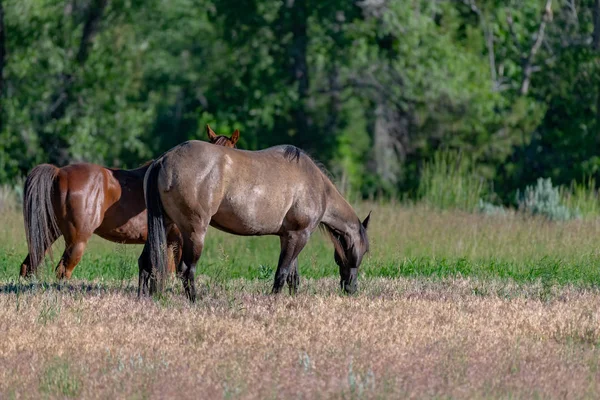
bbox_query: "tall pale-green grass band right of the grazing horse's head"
[358,204,600,261]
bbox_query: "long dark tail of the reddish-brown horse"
[23,164,60,272]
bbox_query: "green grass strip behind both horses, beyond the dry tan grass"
[0,204,600,288]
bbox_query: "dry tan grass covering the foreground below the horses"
[0,279,600,399]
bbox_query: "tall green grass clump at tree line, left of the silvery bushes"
[418,151,488,211]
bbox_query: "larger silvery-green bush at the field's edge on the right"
[517,178,579,221]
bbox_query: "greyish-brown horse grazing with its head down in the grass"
[139,141,370,301]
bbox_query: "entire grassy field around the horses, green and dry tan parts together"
[0,203,600,399]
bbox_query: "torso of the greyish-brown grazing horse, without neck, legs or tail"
[159,141,325,235]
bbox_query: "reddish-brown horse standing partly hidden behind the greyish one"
[21,125,239,279]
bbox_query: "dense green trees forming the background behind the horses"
[0,0,600,200]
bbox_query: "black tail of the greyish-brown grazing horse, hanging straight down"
[145,160,168,291]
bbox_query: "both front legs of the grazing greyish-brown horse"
[272,231,310,293]
